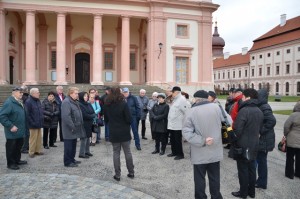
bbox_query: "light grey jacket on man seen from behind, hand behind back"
[182,101,224,164]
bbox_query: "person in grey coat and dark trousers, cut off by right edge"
[283,101,300,179]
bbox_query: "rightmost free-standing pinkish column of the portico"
[118,16,132,85]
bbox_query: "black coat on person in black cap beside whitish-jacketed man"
[150,103,170,133]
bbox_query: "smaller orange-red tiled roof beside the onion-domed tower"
[213,53,250,68]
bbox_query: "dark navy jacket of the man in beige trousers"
[25,96,44,129]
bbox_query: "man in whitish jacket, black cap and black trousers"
[168,86,190,160]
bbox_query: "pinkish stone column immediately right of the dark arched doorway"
[91,14,103,85]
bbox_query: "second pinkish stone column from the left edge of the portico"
[25,10,37,85]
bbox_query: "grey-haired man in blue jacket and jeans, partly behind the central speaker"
[122,88,142,151]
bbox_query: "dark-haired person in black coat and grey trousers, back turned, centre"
[104,88,134,181]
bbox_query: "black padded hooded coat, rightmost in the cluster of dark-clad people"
[258,89,276,152]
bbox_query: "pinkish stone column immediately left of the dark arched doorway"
[54,13,67,85]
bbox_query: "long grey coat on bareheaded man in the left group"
[61,96,85,139]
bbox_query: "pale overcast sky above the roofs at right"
[212,0,300,55]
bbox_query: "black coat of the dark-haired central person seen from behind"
[104,101,131,143]
